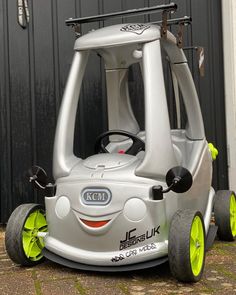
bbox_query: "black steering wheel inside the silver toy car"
[95,130,145,155]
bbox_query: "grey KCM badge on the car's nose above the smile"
[81,188,111,206]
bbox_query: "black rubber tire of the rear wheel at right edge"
[214,190,235,241]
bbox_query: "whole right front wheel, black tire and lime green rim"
[168,210,205,282]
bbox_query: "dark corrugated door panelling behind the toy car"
[0,0,227,222]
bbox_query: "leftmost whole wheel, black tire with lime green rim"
[5,204,47,266]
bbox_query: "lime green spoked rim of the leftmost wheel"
[22,209,47,261]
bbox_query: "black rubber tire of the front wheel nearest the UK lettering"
[168,209,205,282]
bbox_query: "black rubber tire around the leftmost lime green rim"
[5,204,44,266]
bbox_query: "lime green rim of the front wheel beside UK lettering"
[190,215,205,276]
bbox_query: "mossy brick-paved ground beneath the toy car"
[0,227,236,295]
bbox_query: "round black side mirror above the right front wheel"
[166,166,193,193]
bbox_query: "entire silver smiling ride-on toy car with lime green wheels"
[6,3,236,282]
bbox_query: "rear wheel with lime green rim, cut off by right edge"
[214,190,236,241]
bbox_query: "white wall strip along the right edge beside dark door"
[221,0,236,191]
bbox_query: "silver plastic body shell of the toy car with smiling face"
[44,25,214,265]
